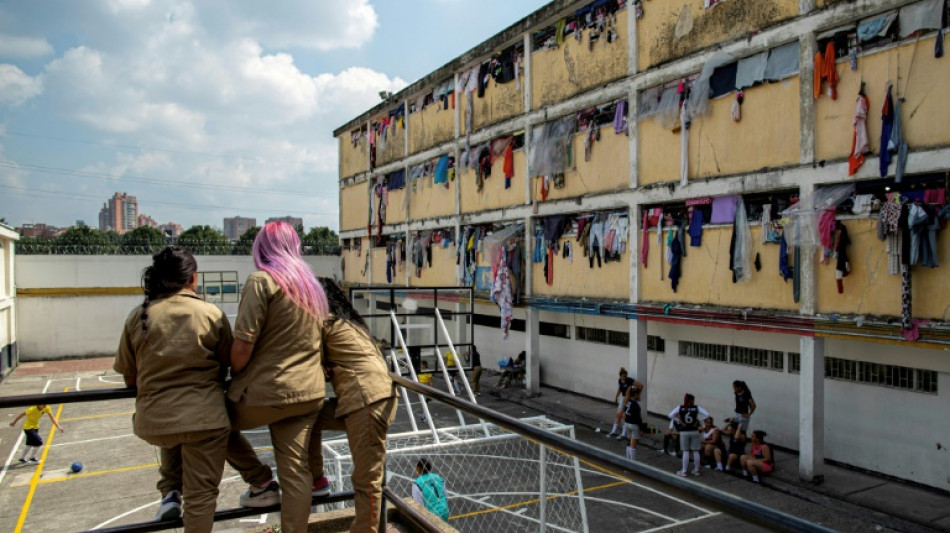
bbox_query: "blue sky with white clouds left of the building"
[0,0,546,229]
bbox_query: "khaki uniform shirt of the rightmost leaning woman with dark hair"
[323,320,396,418]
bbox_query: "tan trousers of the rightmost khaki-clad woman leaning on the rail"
[310,398,398,533]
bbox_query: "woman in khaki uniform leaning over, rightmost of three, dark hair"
[310,278,397,533]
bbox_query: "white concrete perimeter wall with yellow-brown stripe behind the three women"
[15,255,340,361]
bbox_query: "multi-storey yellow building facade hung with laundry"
[334,0,950,490]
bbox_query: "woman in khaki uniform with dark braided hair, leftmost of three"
[113,247,231,533]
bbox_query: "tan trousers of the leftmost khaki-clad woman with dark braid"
[149,428,230,533]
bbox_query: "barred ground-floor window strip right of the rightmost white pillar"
[825,357,937,394]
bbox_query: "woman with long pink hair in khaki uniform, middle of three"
[228,222,328,533]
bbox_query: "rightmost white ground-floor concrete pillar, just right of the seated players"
[798,337,825,484]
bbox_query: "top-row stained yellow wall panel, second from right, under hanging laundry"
[531,11,629,107]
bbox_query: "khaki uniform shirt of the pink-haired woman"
[228,271,326,407]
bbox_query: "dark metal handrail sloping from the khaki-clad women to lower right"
[392,375,834,533]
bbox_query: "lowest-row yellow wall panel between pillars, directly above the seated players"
[636,224,798,311]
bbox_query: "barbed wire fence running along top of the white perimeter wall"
[16,240,340,255]
